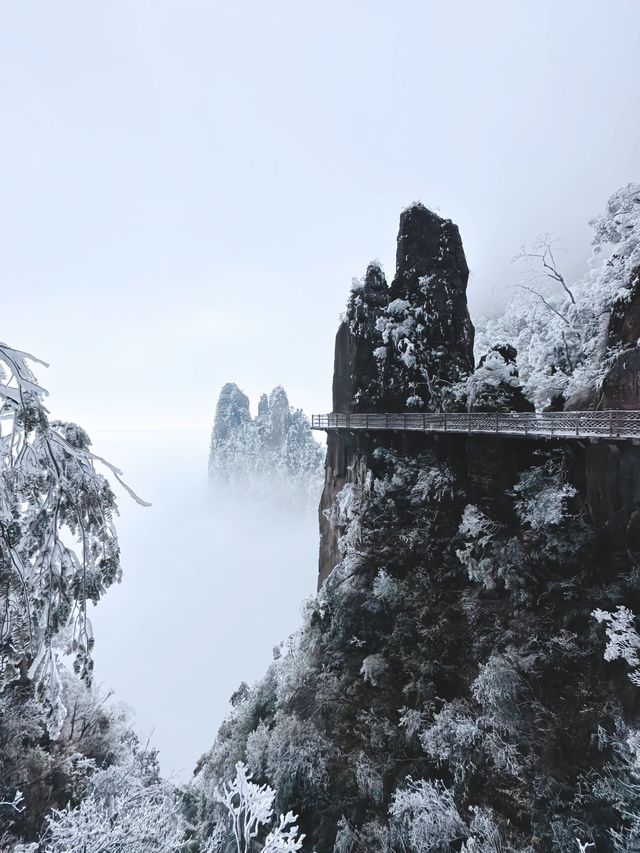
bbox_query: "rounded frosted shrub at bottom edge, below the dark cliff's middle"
[389,778,467,853]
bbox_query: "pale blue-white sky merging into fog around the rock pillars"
[0,0,640,767]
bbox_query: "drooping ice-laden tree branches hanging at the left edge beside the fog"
[0,344,134,738]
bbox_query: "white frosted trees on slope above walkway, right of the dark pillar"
[476,184,640,408]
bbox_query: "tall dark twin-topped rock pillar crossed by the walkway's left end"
[319,204,473,584]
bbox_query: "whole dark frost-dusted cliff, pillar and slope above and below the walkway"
[200,201,640,853]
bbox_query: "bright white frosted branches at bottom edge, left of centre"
[217,761,304,853]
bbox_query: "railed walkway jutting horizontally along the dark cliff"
[311,410,640,441]
